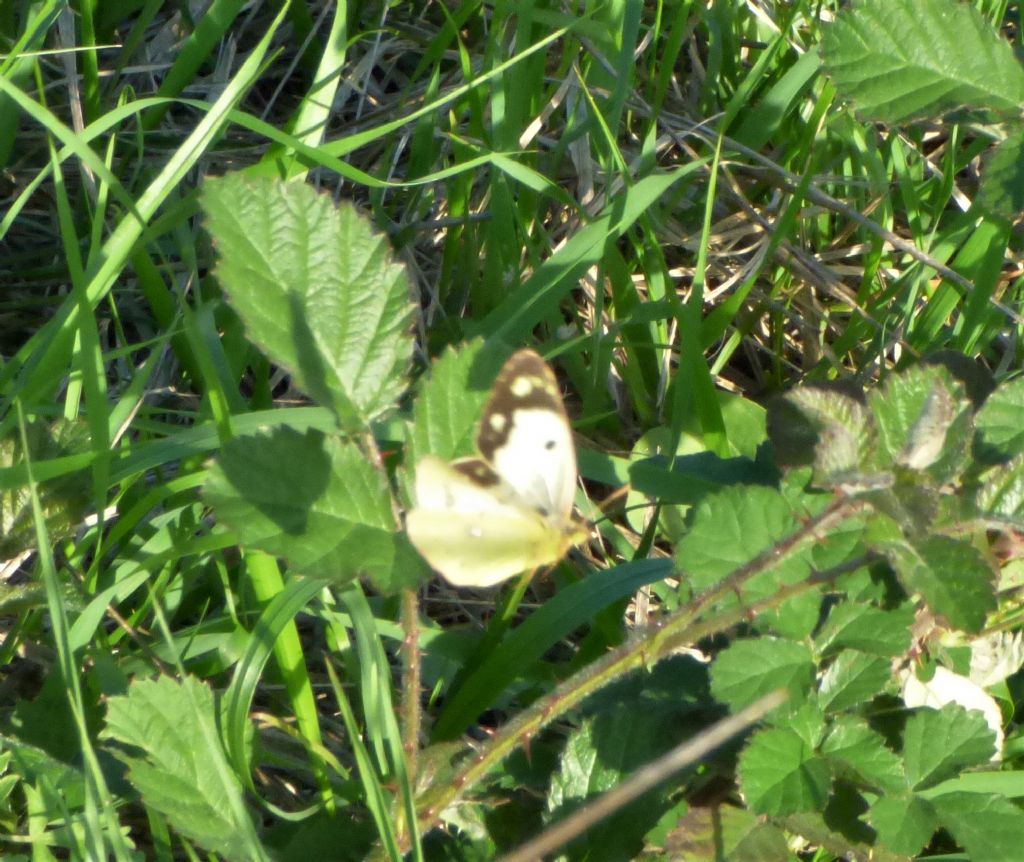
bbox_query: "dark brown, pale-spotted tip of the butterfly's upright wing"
[476,350,568,462]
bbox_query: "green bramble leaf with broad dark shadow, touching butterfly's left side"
[204,427,415,583]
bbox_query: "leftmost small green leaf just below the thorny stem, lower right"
[711,637,814,710]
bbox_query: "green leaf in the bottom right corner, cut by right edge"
[931,792,1024,862]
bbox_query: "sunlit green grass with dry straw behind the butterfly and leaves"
[0,0,1022,859]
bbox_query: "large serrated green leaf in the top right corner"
[823,0,1024,123]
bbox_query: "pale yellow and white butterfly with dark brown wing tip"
[406,350,588,587]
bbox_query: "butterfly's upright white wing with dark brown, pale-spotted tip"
[476,350,577,524]
